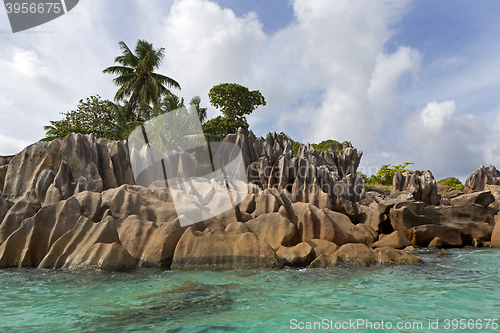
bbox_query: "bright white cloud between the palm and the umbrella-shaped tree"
[162,0,267,116]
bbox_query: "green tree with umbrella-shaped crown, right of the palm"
[203,83,266,137]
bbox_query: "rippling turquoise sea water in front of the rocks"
[0,248,500,332]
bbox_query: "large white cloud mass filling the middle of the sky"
[159,0,421,147]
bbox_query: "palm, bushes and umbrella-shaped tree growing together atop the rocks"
[43,40,266,141]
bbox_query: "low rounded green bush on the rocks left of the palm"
[43,95,117,141]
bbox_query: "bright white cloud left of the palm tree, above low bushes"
[0,2,127,154]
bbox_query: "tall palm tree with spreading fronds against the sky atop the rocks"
[103,39,181,108]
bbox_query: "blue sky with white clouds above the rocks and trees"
[0,0,500,181]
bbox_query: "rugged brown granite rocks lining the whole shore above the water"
[0,131,500,271]
